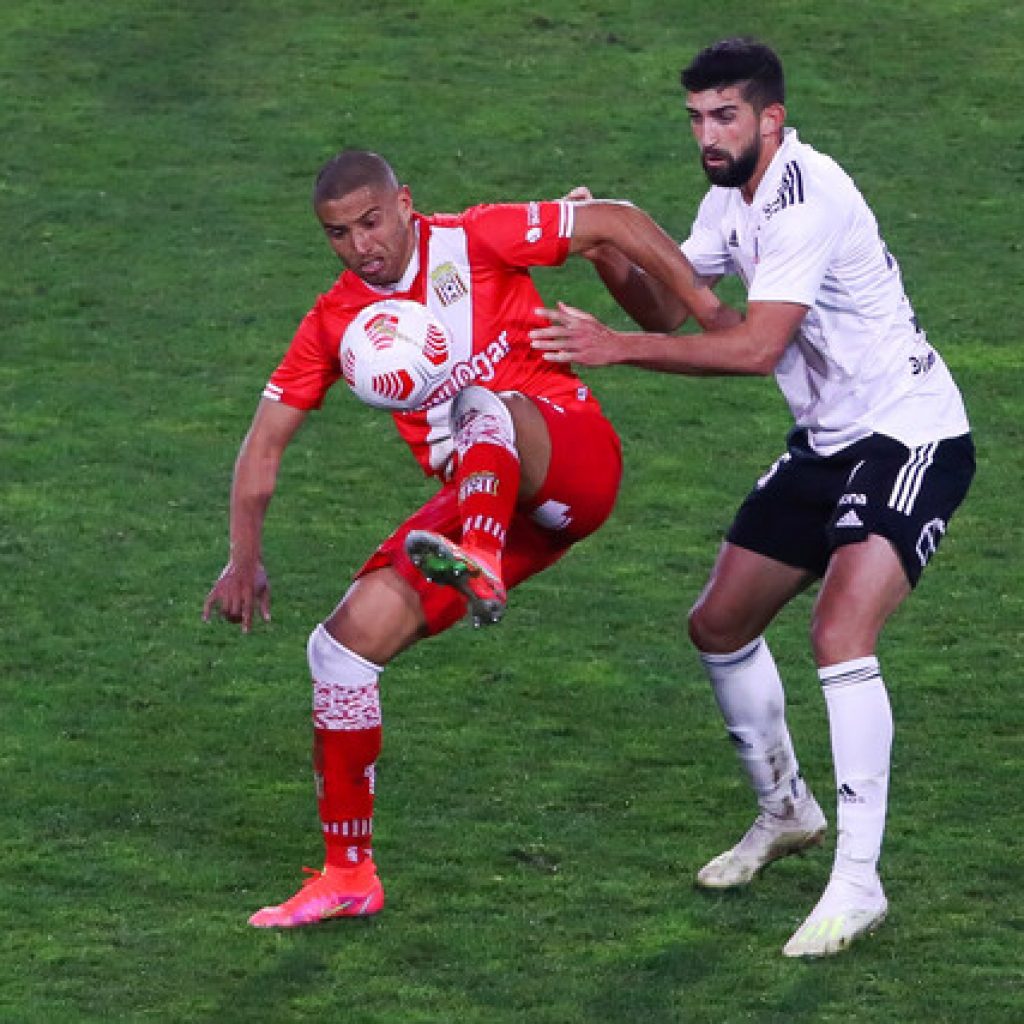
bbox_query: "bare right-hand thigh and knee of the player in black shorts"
[811,534,910,667]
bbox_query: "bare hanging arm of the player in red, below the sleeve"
[203,398,306,633]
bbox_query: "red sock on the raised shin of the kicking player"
[455,443,519,558]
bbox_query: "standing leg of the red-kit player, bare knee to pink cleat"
[249,568,423,928]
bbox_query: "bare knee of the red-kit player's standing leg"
[324,565,427,665]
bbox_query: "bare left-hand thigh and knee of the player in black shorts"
[689,541,815,654]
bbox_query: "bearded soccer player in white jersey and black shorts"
[532,39,975,956]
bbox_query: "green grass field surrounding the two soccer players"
[0,0,1024,1024]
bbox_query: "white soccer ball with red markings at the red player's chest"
[338,299,453,410]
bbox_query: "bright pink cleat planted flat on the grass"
[249,857,384,928]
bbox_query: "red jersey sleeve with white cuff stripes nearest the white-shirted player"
[464,200,573,267]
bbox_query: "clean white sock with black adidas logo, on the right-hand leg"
[818,657,893,886]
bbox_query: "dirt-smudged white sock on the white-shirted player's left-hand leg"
[700,637,807,816]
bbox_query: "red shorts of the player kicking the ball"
[356,398,623,634]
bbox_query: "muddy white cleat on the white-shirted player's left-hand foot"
[697,793,827,889]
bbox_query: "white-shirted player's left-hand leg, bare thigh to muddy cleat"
[689,543,826,889]
